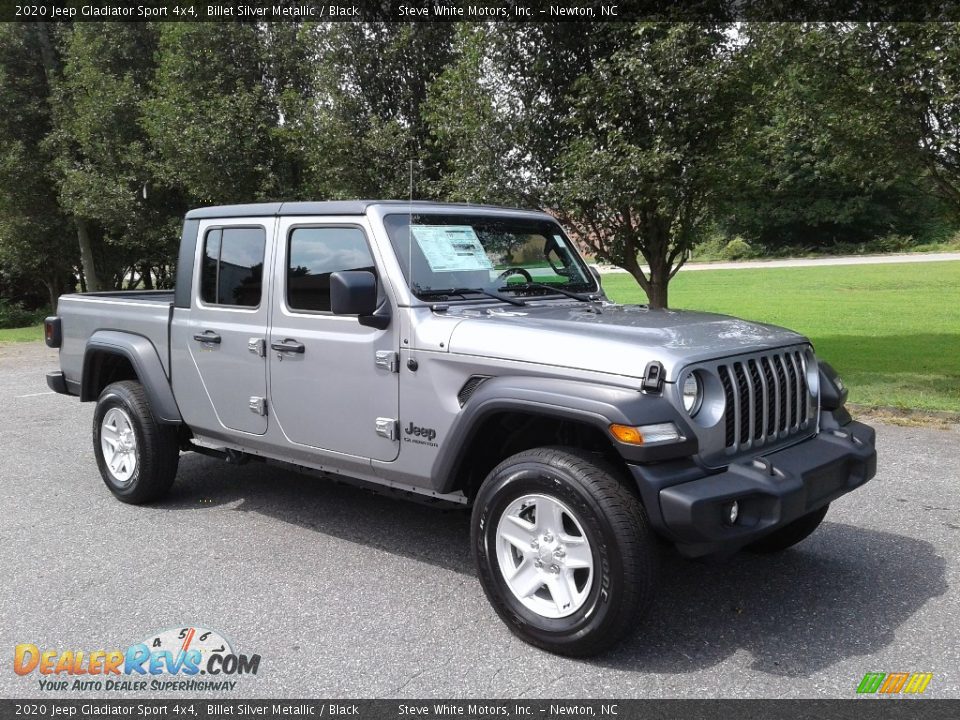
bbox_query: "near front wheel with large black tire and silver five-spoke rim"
[471,448,659,657]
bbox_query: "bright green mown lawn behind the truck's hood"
[603,262,960,412]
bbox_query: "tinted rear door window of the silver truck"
[200,228,267,307]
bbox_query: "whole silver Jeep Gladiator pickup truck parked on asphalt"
[45,201,876,655]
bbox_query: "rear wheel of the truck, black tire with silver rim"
[93,380,180,505]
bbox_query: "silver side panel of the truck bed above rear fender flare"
[57,290,173,384]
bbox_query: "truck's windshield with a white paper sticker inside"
[384,213,598,298]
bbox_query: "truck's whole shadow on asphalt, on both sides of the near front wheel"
[158,455,947,677]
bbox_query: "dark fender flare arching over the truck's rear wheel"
[80,330,183,425]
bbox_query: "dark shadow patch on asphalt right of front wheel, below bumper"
[599,514,948,682]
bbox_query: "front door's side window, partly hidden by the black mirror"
[287,227,376,312]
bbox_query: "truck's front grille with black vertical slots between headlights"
[717,350,811,452]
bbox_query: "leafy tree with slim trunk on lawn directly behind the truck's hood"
[428,23,732,307]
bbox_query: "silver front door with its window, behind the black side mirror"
[267,218,400,461]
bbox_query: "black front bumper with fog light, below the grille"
[631,422,877,556]
